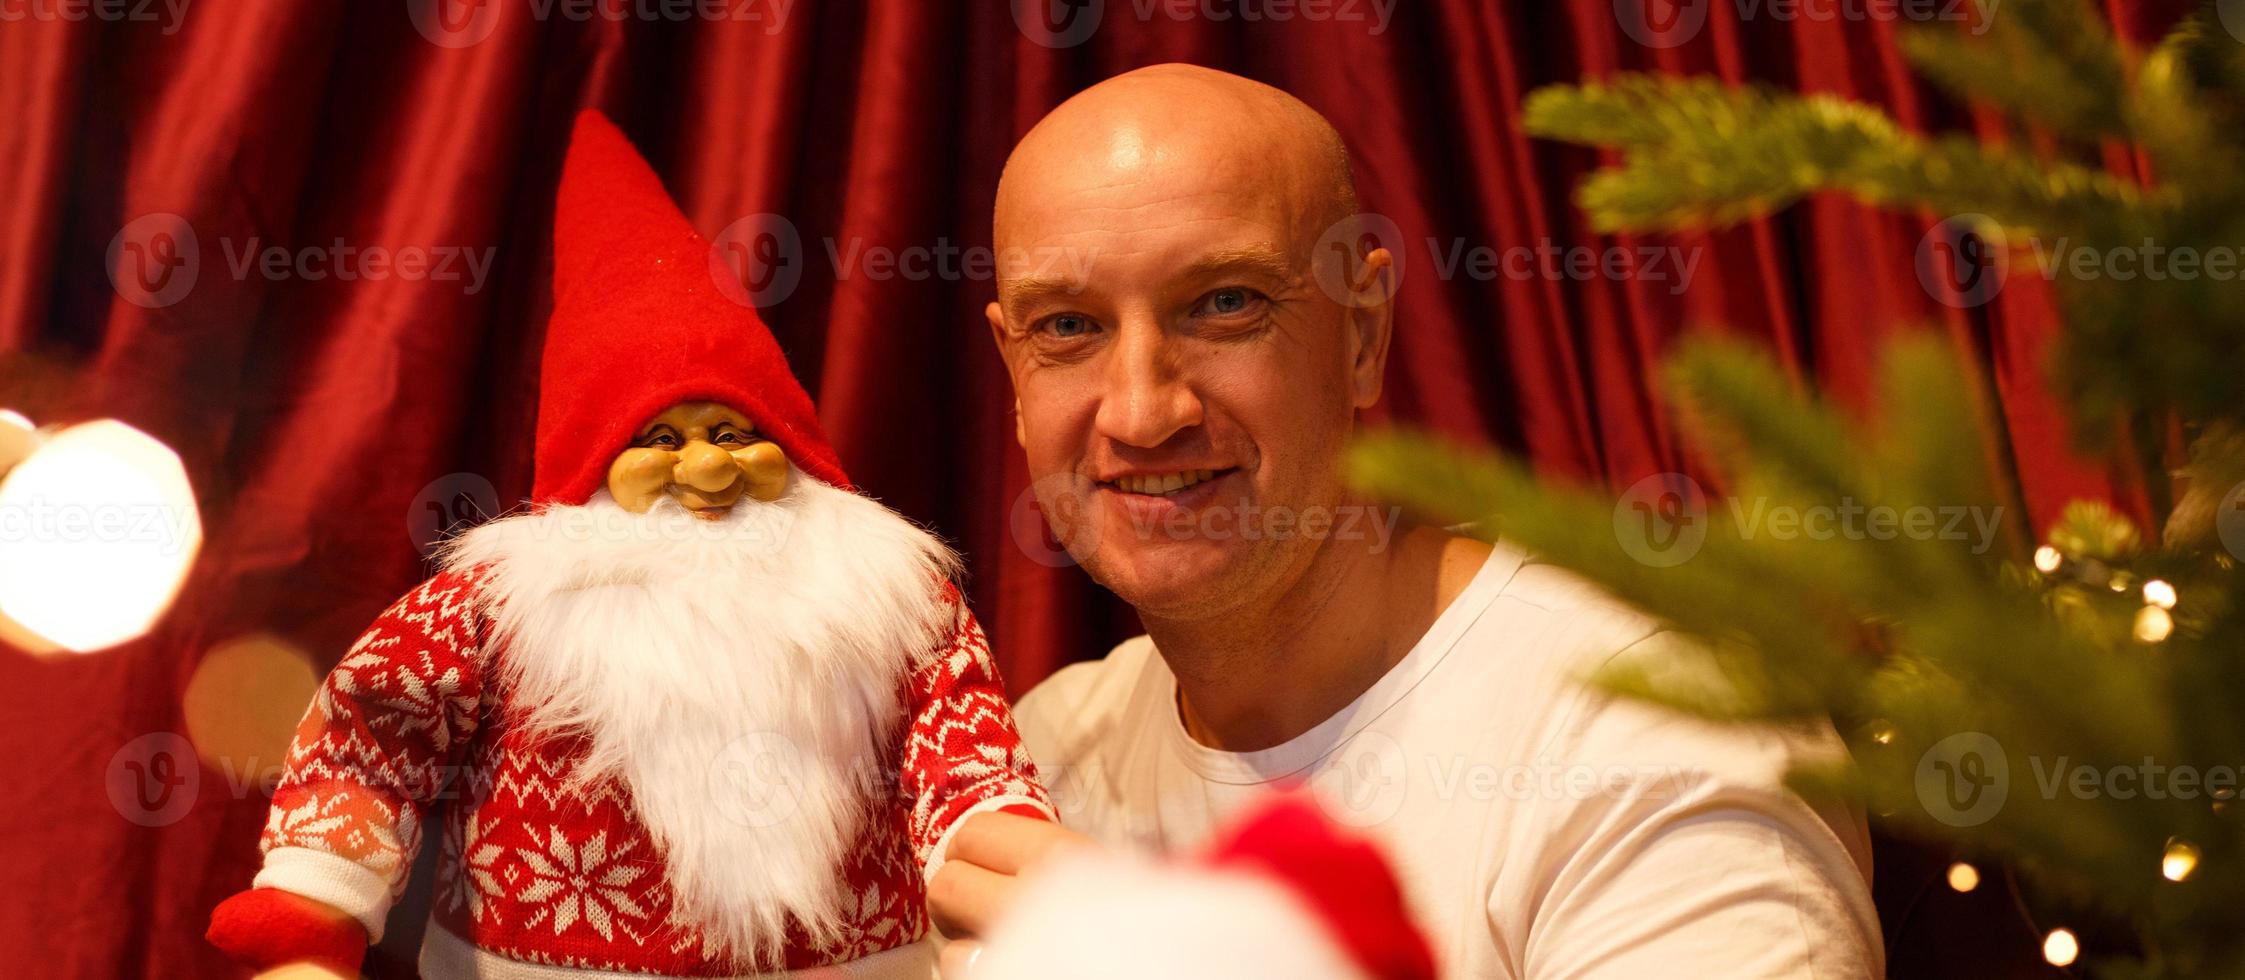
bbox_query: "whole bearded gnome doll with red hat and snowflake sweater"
[211,112,1051,980]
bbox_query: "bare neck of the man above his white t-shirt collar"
[1145,527,1488,751]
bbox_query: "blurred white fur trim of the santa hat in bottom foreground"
[972,850,1369,980]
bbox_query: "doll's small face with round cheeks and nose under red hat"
[608,401,788,520]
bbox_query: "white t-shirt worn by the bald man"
[1015,545,1884,980]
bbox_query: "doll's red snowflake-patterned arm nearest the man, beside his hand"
[902,585,1053,877]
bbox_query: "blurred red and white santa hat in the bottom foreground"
[968,794,1435,980]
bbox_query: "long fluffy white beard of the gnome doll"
[442,471,956,969]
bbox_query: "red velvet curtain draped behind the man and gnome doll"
[0,0,2171,976]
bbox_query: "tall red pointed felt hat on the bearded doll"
[532,110,849,505]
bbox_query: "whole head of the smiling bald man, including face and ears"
[986,65,1394,623]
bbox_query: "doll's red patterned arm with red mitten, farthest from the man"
[209,572,483,976]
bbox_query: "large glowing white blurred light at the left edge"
[0,419,202,653]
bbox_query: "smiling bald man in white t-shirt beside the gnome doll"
[932,65,1881,978]
